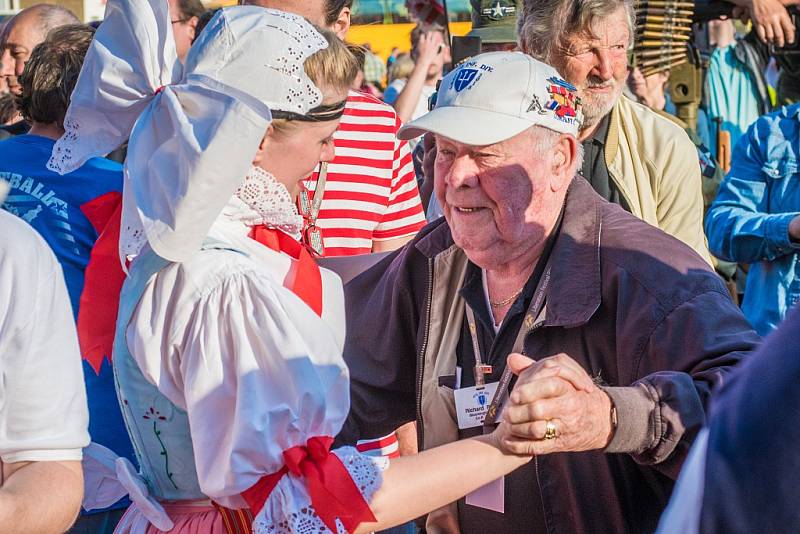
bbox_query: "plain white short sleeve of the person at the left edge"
[0,221,89,463]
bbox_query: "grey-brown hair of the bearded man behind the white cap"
[517,0,636,65]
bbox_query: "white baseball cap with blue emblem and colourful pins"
[397,52,583,146]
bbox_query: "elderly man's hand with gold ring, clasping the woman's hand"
[501,354,613,455]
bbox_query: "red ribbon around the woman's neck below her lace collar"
[250,225,322,316]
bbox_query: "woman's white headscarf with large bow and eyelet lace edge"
[48,0,328,261]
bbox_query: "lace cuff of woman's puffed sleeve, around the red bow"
[253,447,389,534]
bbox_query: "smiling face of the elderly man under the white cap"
[434,131,568,269]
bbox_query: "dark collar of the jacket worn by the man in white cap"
[415,177,602,327]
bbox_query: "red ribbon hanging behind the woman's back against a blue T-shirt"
[78,191,125,375]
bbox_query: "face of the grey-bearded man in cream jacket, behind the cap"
[552,7,630,127]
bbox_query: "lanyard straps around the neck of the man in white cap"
[466,258,552,433]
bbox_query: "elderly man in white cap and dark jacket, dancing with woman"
[339,52,759,533]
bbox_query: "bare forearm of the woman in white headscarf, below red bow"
[356,432,530,532]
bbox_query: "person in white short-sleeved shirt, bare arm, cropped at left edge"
[0,186,89,533]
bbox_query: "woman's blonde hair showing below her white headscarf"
[272,28,359,133]
